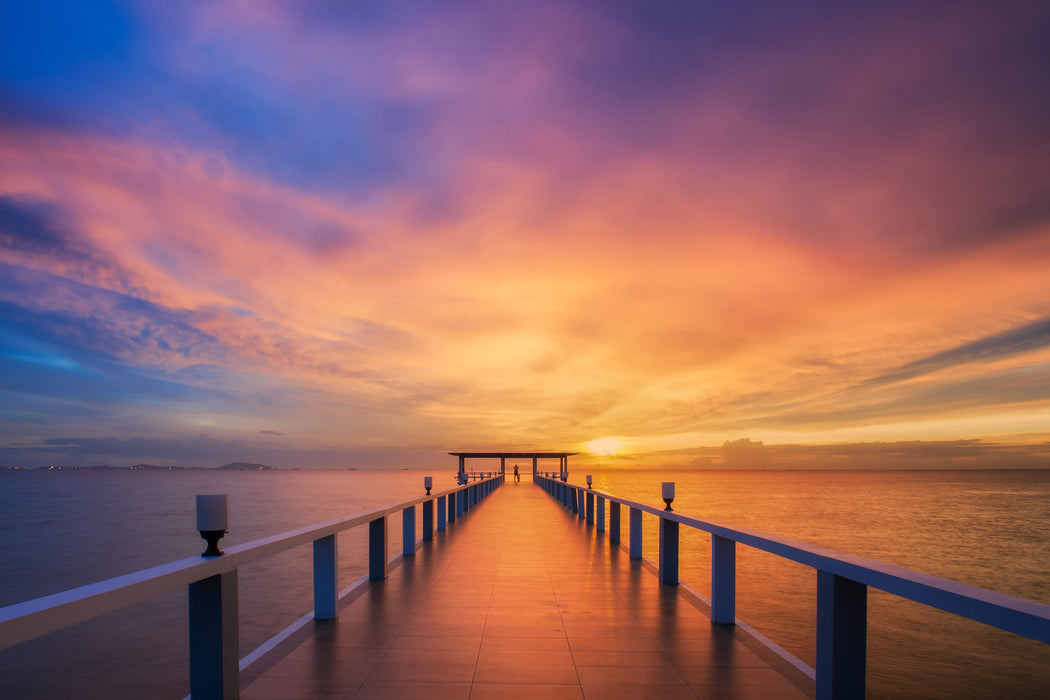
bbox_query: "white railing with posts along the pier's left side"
[0,474,504,700]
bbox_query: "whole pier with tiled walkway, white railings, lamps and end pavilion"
[0,459,1050,700]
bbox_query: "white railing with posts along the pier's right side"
[536,474,1050,699]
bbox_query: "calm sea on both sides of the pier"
[0,464,1050,700]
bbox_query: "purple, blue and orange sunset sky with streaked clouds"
[0,0,1050,468]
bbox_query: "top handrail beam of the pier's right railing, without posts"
[540,475,1050,643]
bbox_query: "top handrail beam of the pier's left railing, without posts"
[0,474,501,650]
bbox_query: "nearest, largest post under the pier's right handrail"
[817,570,867,700]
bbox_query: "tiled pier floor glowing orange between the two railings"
[242,476,812,700]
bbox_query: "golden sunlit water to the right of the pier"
[571,469,1050,698]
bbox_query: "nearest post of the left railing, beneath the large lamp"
[189,570,240,700]
